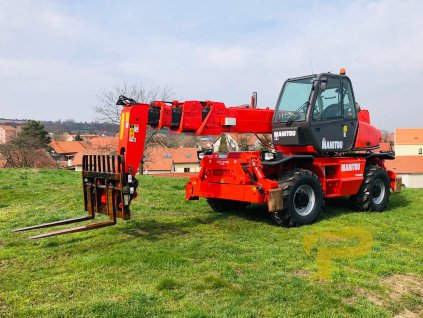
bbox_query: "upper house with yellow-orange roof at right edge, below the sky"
[395,128,423,157]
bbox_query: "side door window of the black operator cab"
[313,78,342,120]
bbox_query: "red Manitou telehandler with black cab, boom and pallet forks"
[17,69,401,238]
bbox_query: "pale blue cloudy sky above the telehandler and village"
[0,0,423,130]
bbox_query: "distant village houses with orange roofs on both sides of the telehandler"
[0,121,423,188]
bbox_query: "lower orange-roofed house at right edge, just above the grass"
[385,156,423,188]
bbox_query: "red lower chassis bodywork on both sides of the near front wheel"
[186,152,372,203]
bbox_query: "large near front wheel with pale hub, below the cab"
[271,169,323,227]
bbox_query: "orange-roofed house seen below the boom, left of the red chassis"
[143,147,200,174]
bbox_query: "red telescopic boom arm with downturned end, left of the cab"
[119,98,273,176]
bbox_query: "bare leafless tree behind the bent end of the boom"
[94,83,174,174]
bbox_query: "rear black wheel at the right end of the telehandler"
[350,166,391,211]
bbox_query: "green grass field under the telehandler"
[0,169,423,317]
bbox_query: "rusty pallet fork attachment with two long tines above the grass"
[14,155,132,239]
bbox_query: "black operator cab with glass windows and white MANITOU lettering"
[272,73,358,152]
